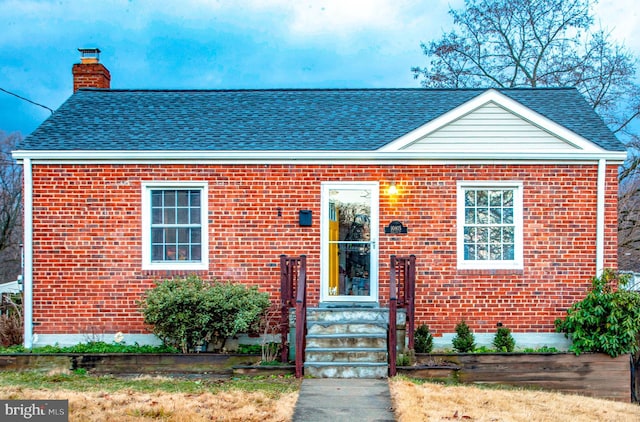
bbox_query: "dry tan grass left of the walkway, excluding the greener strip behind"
[0,387,298,422]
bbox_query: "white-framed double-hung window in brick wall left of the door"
[142,182,208,270]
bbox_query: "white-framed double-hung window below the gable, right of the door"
[457,182,523,269]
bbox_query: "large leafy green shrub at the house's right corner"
[555,269,640,357]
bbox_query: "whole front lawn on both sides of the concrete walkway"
[0,372,640,422]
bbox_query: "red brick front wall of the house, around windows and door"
[28,165,617,335]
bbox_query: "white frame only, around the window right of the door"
[456,181,524,270]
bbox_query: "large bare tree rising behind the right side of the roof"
[411,0,640,270]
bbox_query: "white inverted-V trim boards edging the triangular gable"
[378,88,606,152]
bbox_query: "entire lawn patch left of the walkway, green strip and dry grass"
[0,372,300,422]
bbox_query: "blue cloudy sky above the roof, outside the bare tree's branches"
[0,0,640,135]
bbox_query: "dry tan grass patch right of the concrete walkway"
[389,378,640,422]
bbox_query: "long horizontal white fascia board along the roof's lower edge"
[13,150,627,164]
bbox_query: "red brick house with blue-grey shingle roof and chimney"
[14,52,626,362]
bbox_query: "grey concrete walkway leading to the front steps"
[293,378,395,422]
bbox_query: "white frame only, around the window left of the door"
[141,181,209,271]
